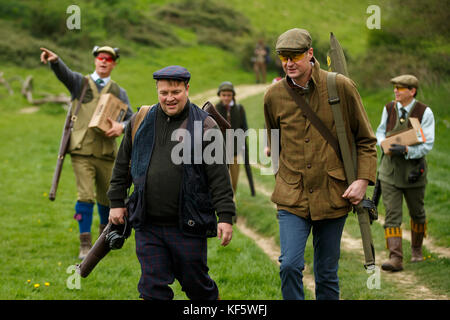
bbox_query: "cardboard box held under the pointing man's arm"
[89,93,128,132]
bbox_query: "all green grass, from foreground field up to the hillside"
[0,0,450,300]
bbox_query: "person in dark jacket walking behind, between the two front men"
[216,81,248,199]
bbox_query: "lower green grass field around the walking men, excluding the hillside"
[0,69,450,300]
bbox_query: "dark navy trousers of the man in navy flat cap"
[135,225,219,300]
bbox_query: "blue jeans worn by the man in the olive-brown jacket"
[278,210,347,300]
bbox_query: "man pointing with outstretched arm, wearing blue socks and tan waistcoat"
[41,46,133,259]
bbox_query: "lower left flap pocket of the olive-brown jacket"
[271,166,303,206]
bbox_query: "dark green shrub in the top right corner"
[349,0,450,87]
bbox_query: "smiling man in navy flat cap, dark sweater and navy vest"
[108,66,235,300]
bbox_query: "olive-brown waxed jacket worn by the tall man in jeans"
[264,60,377,220]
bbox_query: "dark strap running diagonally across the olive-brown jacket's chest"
[283,78,340,156]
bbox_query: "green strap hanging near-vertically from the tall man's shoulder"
[327,72,356,184]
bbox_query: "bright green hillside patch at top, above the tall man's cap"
[228,0,377,56]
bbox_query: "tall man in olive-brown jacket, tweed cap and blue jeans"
[264,28,377,300]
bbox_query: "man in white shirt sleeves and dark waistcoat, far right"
[377,75,434,271]
